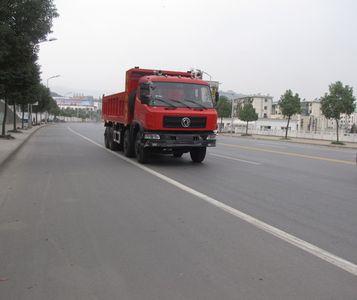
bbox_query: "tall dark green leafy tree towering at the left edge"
[0,0,57,135]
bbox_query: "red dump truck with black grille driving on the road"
[102,67,218,163]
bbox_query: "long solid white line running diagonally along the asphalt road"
[67,126,357,276]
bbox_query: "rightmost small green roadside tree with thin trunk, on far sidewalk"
[321,81,356,143]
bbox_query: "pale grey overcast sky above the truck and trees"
[39,0,357,101]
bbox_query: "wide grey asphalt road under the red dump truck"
[0,124,357,300]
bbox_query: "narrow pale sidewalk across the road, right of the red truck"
[219,133,357,150]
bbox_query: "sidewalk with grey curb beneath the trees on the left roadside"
[0,125,45,171]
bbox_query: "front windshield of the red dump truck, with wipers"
[149,82,213,108]
